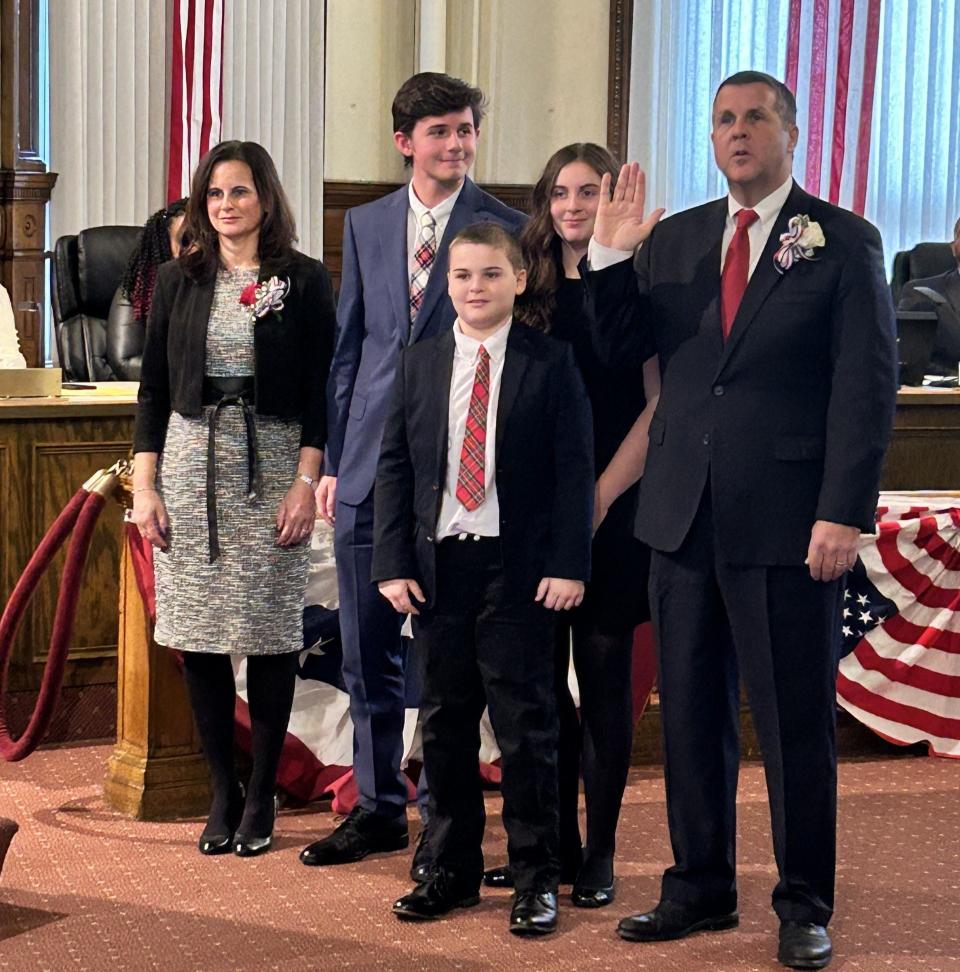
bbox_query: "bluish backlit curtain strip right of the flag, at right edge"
[865,0,960,263]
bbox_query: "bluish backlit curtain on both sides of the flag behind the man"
[628,0,960,267]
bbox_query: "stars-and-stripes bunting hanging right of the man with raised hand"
[837,492,960,757]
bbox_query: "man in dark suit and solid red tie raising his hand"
[587,72,896,968]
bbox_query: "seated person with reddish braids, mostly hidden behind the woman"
[107,199,187,381]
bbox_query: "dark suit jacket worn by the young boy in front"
[371,322,594,604]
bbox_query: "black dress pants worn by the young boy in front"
[414,537,559,891]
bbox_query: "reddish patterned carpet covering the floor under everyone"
[0,746,960,972]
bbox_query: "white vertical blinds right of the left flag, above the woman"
[223,0,325,258]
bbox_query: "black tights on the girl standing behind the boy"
[555,621,633,886]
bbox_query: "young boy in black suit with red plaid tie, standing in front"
[373,223,593,934]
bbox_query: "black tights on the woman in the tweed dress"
[183,651,298,837]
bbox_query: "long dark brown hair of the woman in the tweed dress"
[180,141,297,280]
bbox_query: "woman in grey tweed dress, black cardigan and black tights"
[133,142,334,857]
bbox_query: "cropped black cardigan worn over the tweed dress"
[133,253,335,452]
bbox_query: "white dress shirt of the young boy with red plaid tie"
[437,318,513,540]
